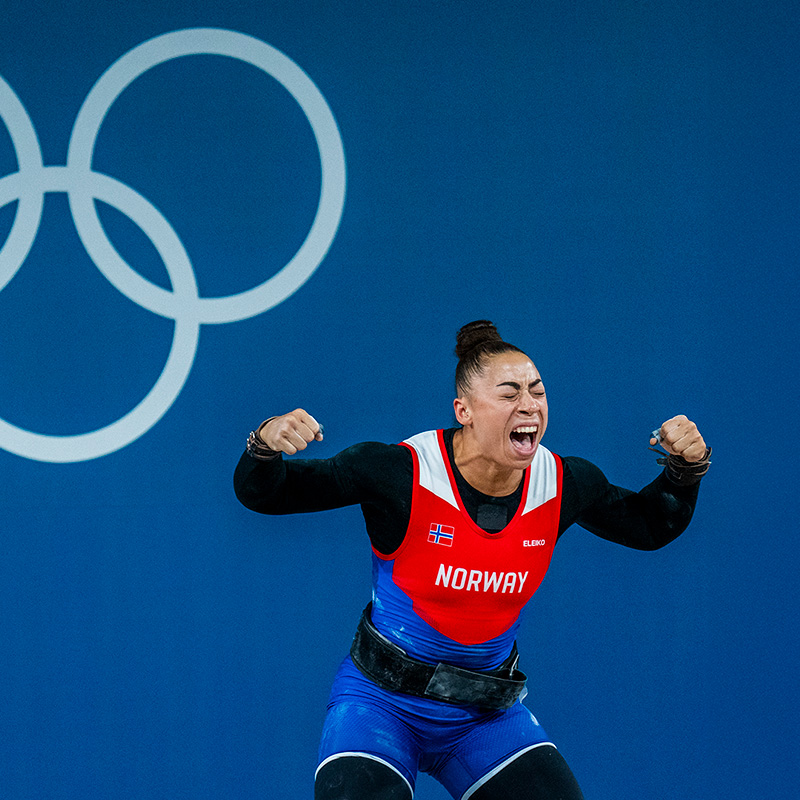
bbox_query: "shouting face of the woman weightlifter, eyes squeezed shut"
[454,352,547,469]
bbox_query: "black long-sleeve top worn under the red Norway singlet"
[234,428,699,555]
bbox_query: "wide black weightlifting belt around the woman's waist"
[350,603,526,709]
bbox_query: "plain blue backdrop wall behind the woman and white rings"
[0,0,800,800]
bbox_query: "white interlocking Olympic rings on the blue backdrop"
[0,28,346,463]
